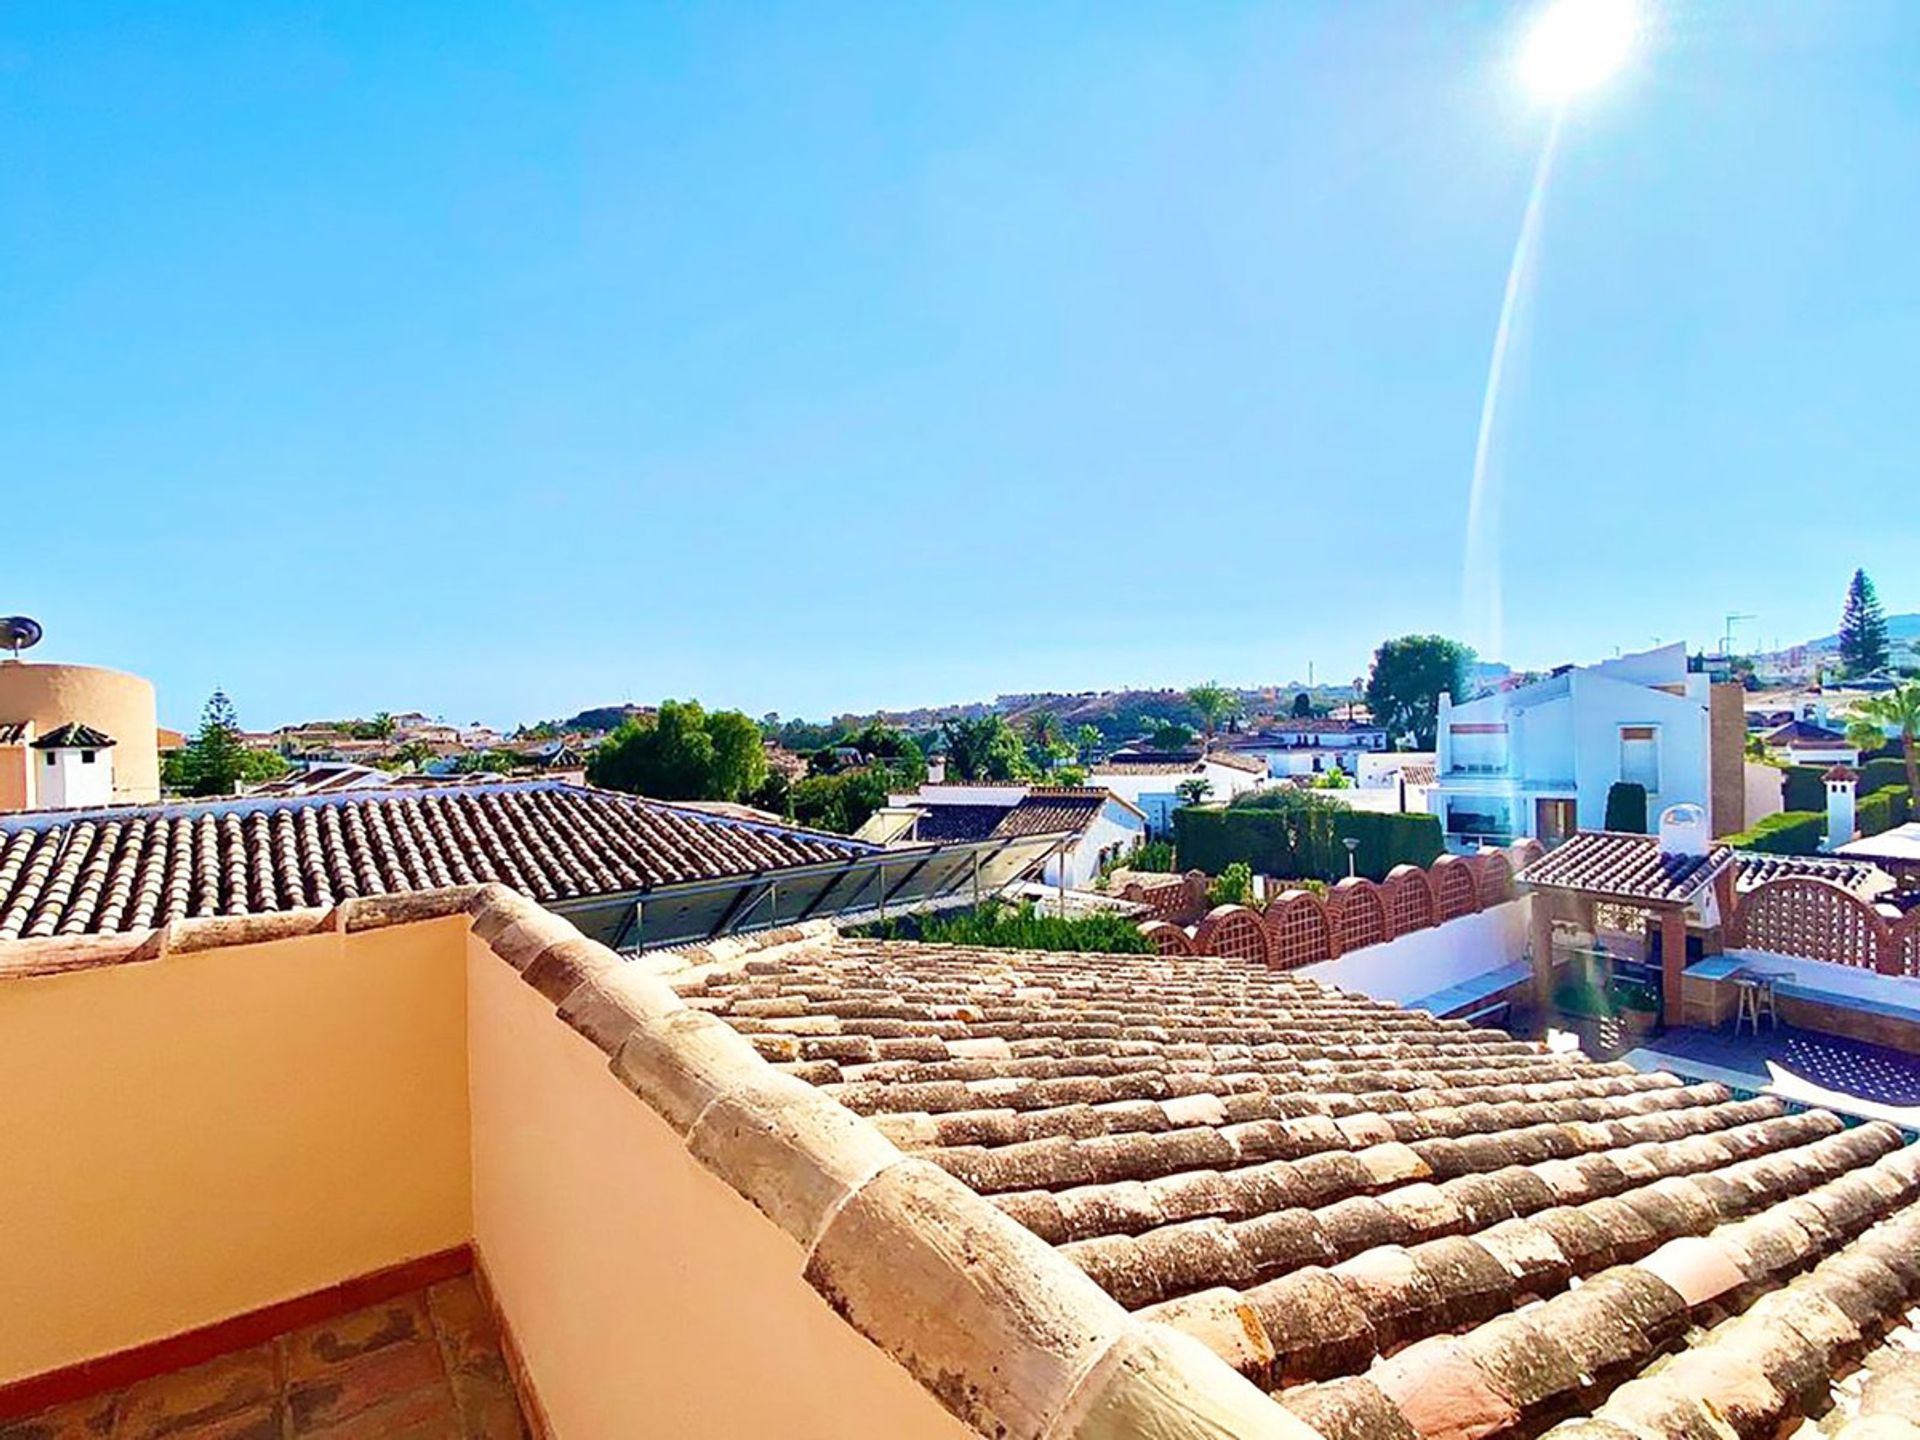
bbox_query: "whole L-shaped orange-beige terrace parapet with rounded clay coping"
[0,885,1315,1440]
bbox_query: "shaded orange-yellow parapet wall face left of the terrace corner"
[0,918,470,1384]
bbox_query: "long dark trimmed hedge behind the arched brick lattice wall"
[1173,804,1446,881]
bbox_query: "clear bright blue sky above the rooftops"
[0,0,1920,726]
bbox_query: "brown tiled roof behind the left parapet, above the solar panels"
[0,780,874,939]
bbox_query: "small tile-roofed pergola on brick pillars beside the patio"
[1519,831,1734,1025]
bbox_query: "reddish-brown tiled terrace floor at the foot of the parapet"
[0,1275,526,1440]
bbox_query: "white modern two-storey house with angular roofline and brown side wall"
[1428,645,1743,849]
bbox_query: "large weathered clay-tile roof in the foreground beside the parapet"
[679,941,1920,1440]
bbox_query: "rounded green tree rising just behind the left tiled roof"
[588,701,766,801]
